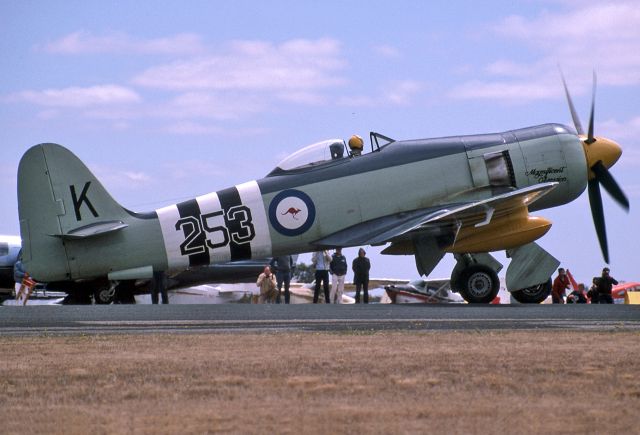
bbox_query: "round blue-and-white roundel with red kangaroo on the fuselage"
[269,189,316,236]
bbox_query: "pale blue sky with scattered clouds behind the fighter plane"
[0,0,640,282]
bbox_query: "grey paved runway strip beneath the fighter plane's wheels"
[0,304,640,336]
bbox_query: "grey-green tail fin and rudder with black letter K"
[18,143,129,282]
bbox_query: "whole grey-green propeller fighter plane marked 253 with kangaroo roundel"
[18,73,629,303]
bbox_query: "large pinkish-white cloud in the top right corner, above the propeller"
[450,2,640,102]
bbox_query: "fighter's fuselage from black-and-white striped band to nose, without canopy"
[157,124,587,269]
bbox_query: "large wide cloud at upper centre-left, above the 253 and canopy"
[133,39,345,92]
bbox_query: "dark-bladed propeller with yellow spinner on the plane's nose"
[560,71,629,264]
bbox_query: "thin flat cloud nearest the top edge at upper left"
[40,31,204,55]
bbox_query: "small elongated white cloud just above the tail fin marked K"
[11,85,141,108]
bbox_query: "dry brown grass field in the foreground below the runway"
[0,331,640,434]
